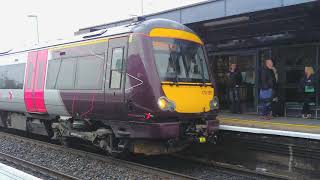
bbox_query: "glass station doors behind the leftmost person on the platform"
[210,52,257,113]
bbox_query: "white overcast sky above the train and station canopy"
[0,0,205,51]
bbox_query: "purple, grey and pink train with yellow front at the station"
[0,19,219,155]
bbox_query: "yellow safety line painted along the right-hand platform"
[219,118,320,129]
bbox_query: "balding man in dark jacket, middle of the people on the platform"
[259,59,277,120]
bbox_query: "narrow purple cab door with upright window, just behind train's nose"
[105,37,128,120]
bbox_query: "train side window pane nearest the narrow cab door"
[75,54,104,89]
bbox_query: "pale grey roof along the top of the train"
[0,19,194,56]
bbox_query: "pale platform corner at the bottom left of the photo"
[0,163,40,180]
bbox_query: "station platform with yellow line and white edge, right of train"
[218,113,320,140]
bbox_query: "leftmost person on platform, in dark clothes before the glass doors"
[228,64,242,114]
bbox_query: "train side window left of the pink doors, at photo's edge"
[0,64,25,89]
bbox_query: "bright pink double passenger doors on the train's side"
[24,50,48,113]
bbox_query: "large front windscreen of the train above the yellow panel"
[152,38,210,83]
